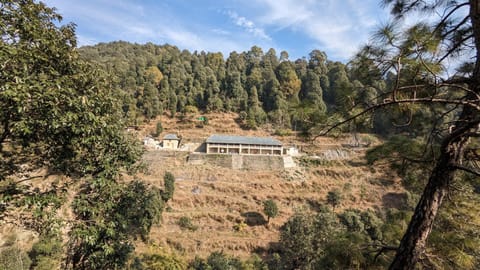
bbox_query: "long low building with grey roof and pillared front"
[206,134,283,156]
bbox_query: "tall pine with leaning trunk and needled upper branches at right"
[346,0,480,269]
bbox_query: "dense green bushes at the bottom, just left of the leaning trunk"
[267,207,404,269]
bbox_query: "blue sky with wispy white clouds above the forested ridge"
[43,0,388,62]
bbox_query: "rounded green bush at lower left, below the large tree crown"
[70,179,163,269]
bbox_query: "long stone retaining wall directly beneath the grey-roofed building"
[188,153,285,170]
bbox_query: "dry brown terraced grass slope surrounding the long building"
[134,114,404,258]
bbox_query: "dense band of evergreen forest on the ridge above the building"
[80,41,394,136]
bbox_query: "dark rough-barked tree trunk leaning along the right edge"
[389,0,480,270]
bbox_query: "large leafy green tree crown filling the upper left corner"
[0,1,142,180]
